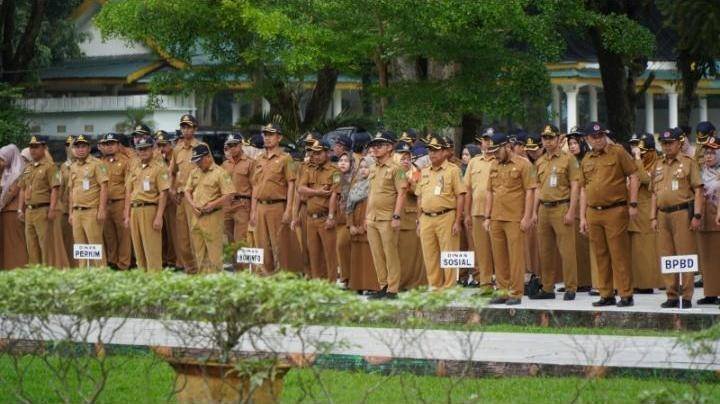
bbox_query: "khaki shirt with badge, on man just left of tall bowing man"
[535,150,580,202]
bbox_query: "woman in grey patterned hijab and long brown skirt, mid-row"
[346,157,380,293]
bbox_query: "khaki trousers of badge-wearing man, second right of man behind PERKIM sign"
[130,205,162,272]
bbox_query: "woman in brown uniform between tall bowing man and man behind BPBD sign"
[628,134,663,293]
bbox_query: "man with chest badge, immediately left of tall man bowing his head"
[530,125,580,300]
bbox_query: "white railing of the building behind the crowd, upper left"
[19,94,195,113]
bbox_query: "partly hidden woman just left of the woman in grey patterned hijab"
[335,152,355,287]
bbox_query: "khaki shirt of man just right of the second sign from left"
[252,150,296,201]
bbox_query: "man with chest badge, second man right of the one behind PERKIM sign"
[124,137,170,271]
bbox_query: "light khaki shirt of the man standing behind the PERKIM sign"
[70,156,108,208]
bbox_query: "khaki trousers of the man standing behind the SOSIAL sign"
[420,210,460,289]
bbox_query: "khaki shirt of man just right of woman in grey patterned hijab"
[365,158,407,221]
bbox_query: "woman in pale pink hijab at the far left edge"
[0,144,28,269]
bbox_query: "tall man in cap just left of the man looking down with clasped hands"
[169,115,201,273]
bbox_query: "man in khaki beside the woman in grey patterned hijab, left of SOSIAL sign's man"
[365,131,407,299]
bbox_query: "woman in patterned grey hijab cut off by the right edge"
[697,138,720,304]
